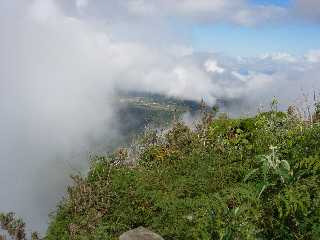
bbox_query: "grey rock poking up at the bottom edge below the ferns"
[119,227,164,240]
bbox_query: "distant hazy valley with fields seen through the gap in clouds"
[114,93,201,149]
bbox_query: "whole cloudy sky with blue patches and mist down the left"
[0,0,320,233]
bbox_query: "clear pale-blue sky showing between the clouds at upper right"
[189,0,320,56]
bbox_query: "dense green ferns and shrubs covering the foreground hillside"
[46,108,320,240]
